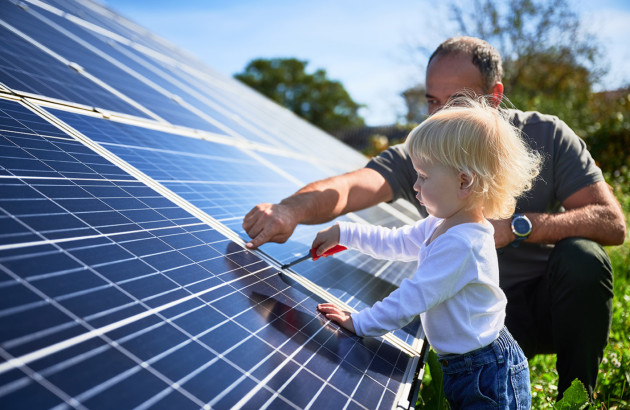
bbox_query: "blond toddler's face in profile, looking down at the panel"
[411,156,462,218]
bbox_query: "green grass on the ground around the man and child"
[417,169,630,410]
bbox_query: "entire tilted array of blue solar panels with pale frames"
[0,0,426,409]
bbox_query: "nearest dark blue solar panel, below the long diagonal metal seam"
[0,100,424,408]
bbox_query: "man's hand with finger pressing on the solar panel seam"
[243,203,298,249]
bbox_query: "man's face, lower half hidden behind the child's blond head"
[426,55,486,115]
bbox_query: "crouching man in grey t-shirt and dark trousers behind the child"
[243,37,626,398]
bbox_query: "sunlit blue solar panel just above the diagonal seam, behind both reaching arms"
[42,110,418,340]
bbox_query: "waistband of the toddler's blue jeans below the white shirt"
[438,327,515,372]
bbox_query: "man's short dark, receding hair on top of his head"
[429,36,503,93]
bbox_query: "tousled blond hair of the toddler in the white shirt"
[406,97,542,218]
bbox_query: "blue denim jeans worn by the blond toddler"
[438,327,532,409]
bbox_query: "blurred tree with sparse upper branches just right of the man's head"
[451,0,606,135]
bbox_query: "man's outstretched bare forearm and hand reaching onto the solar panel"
[243,168,393,249]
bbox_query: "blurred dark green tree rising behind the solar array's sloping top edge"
[234,58,365,132]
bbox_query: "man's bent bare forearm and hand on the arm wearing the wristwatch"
[492,181,626,248]
